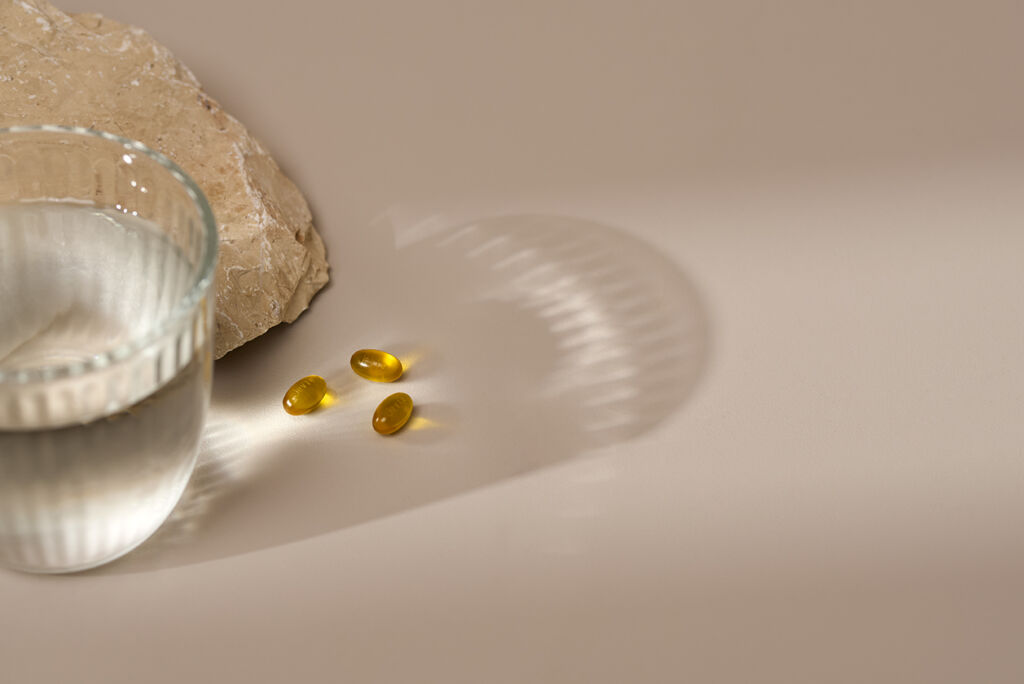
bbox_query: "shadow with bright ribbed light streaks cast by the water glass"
[96,215,708,572]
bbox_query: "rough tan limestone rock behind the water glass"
[0,0,328,357]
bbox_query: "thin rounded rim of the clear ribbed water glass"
[0,124,219,385]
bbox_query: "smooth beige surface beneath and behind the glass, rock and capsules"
[0,0,1024,683]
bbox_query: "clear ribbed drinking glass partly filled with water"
[0,126,217,572]
